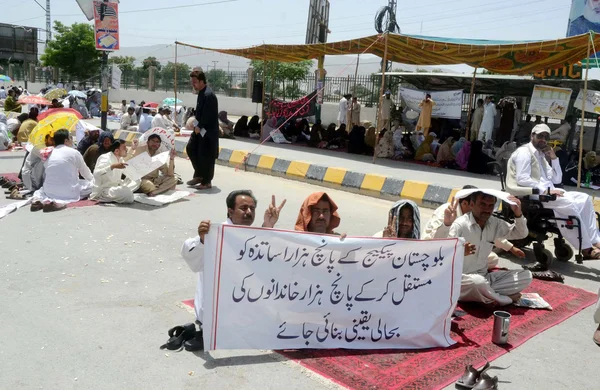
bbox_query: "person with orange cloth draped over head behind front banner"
[294,192,340,235]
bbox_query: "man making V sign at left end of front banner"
[181,190,285,351]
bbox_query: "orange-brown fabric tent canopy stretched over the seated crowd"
[176,32,600,75]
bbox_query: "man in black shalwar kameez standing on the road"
[186,68,219,190]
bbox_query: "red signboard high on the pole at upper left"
[94,0,119,51]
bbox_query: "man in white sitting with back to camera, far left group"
[31,129,94,211]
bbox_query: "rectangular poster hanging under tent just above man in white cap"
[528,85,573,119]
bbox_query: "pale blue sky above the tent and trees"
[0,0,588,76]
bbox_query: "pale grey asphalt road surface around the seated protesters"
[0,153,600,389]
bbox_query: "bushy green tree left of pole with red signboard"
[41,21,102,81]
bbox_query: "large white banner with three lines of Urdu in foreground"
[202,224,464,350]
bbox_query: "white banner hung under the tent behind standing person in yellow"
[398,88,463,119]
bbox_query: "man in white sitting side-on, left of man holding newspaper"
[90,139,140,203]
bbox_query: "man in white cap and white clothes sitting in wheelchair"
[506,123,600,260]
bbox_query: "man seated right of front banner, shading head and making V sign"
[449,190,532,306]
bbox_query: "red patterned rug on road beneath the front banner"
[183,280,597,390]
